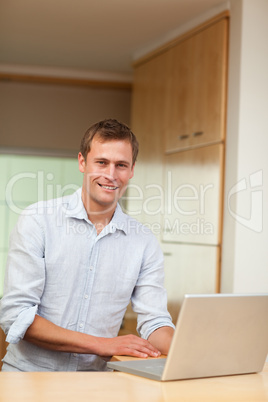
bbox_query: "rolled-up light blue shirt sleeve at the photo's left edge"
[0,208,45,343]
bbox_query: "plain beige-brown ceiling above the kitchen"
[0,0,224,74]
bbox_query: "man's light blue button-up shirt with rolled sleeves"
[0,189,174,371]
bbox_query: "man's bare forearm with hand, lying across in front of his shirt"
[24,315,159,357]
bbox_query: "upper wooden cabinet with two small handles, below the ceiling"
[162,18,228,153]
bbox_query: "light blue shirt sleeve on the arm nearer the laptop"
[132,234,175,339]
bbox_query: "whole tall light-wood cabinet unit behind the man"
[125,13,228,328]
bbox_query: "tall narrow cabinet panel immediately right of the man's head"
[126,51,166,237]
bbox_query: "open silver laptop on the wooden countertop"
[108,294,268,381]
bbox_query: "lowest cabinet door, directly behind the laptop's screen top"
[162,243,220,322]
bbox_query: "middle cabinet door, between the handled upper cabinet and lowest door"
[163,144,223,245]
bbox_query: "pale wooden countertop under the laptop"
[0,363,268,402]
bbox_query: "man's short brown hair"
[80,119,139,165]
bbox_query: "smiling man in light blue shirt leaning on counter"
[0,120,174,371]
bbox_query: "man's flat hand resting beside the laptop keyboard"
[96,335,161,358]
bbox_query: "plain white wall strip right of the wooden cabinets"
[221,0,268,293]
